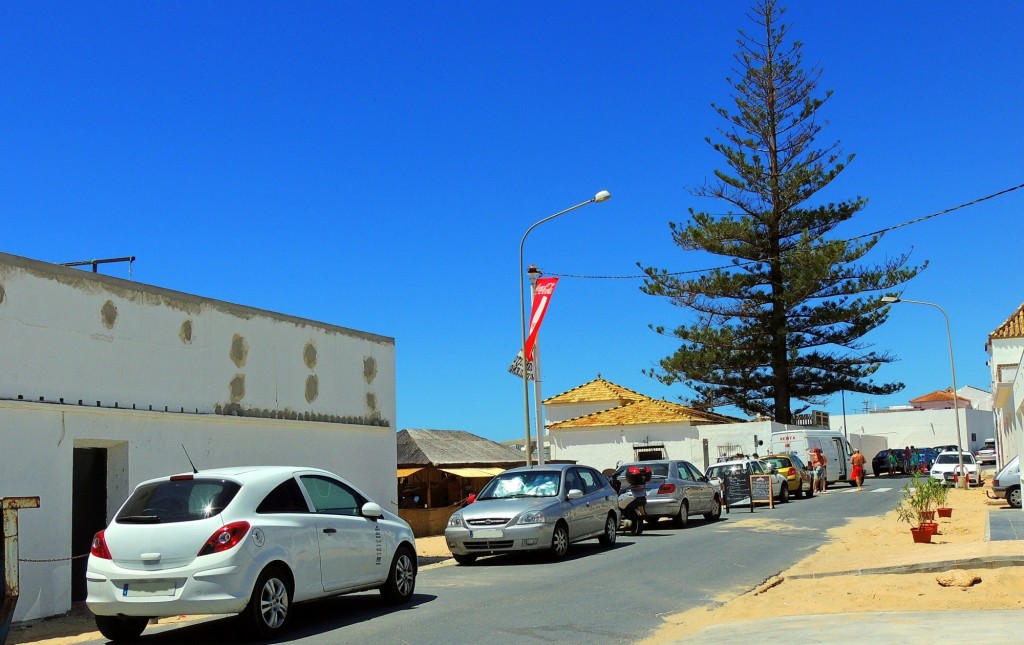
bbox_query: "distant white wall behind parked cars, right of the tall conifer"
[830,409,995,453]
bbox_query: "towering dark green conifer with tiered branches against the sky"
[642,0,924,423]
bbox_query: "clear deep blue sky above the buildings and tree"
[0,0,1024,440]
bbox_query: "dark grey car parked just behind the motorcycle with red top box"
[611,460,722,528]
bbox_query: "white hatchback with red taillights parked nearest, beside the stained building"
[86,467,417,641]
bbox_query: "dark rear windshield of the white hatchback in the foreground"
[115,478,242,524]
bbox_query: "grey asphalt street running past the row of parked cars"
[75,477,906,645]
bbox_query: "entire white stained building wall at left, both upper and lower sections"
[0,254,396,620]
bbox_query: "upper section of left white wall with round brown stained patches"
[0,254,395,427]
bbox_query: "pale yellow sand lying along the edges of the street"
[7,485,1024,645]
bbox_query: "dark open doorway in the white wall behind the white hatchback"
[71,447,106,602]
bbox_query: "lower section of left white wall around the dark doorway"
[0,401,397,621]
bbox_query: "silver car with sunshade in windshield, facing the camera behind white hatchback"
[444,464,618,564]
